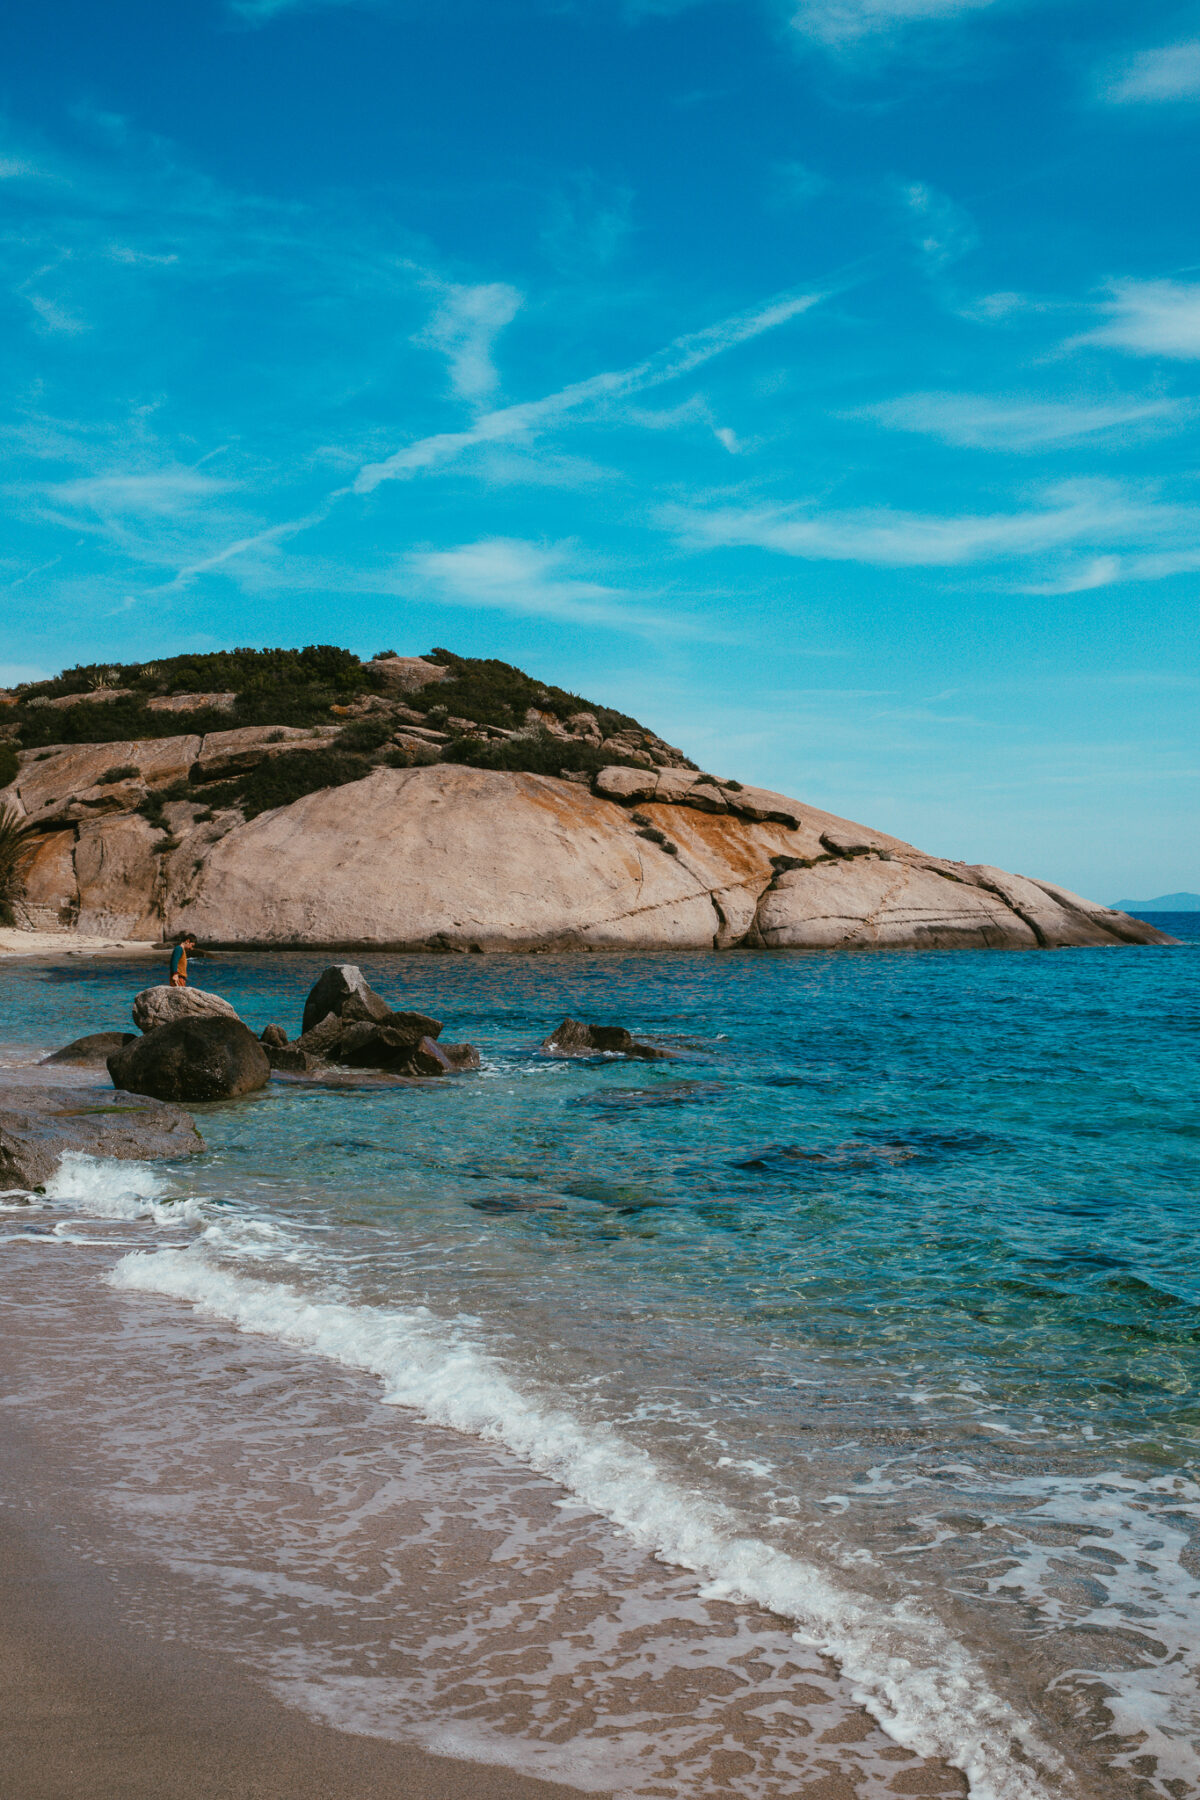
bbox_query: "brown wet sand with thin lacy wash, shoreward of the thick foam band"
[0,1210,966,1800]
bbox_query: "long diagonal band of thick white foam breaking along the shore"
[110,1228,1072,1800]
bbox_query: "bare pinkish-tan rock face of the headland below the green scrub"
[0,734,1169,957]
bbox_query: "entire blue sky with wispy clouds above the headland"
[0,0,1200,900]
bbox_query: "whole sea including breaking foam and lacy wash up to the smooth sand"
[0,914,1200,1800]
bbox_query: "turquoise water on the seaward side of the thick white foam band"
[0,914,1200,1795]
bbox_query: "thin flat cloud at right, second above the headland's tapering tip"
[849,392,1196,452]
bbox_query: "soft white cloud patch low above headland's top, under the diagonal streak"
[407,538,684,634]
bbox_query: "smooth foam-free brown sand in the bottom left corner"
[0,1504,597,1800]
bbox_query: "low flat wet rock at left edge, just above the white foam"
[0,1080,203,1188]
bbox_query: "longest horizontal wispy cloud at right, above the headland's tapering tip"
[664,482,1200,569]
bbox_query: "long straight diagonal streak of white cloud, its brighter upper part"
[354,293,820,493]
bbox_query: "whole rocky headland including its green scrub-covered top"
[0,646,1171,952]
